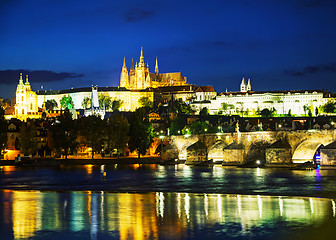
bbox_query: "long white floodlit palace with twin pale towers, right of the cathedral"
[192,78,331,116]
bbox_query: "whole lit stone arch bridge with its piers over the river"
[162,130,336,165]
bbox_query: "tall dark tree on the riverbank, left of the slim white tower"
[51,109,78,159]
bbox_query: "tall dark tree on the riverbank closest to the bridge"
[128,108,154,158]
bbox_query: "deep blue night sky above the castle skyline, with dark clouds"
[0,0,336,98]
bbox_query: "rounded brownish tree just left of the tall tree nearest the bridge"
[106,115,130,156]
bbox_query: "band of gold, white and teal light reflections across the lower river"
[0,190,335,239]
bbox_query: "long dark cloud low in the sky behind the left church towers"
[0,69,84,84]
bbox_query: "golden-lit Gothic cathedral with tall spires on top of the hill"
[120,48,187,90]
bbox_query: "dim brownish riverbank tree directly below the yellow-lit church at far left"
[20,122,37,156]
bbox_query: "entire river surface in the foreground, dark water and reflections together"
[0,165,336,240]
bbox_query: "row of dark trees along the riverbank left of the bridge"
[0,108,153,158]
